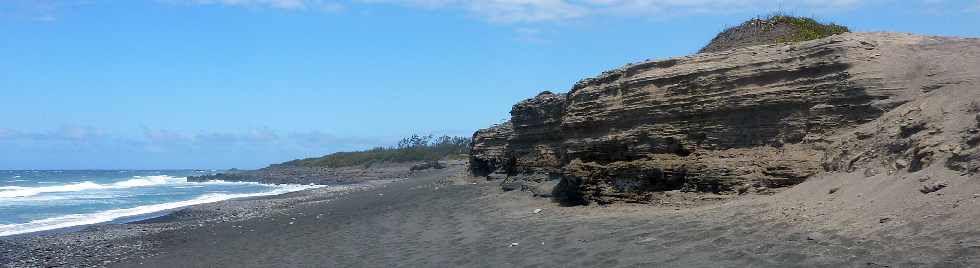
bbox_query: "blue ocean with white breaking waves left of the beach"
[0,170,320,236]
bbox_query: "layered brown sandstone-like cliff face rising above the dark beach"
[470,33,980,205]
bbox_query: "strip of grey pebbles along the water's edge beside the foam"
[0,170,422,267]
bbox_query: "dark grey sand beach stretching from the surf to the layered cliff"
[4,160,980,267]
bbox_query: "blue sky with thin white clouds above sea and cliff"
[0,0,980,169]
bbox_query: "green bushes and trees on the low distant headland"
[280,135,470,168]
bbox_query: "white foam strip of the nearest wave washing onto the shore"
[0,185,324,236]
